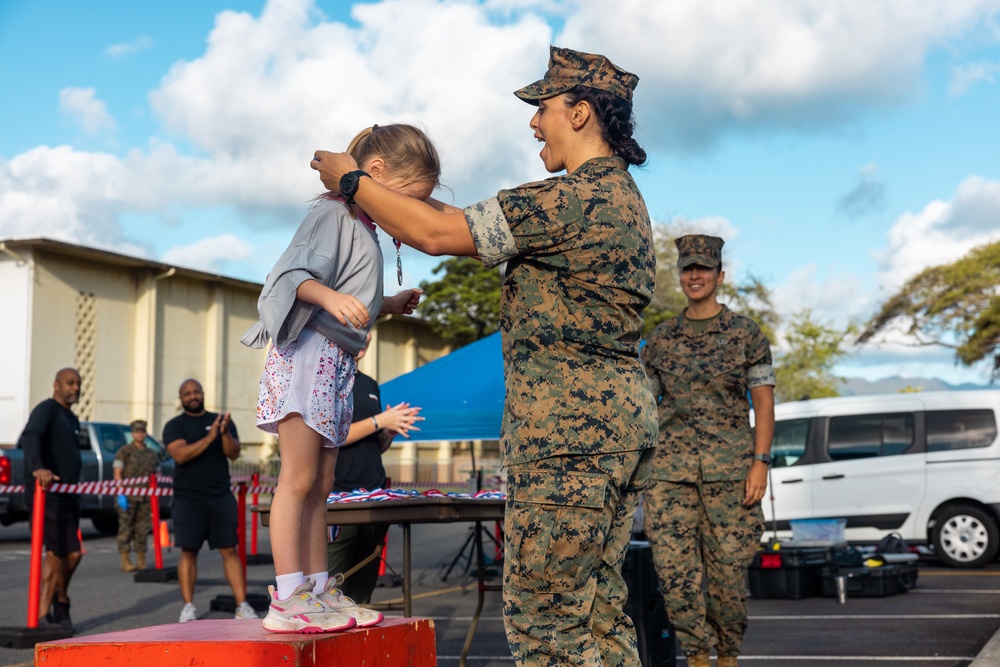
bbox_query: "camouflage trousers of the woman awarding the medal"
[503,449,653,667]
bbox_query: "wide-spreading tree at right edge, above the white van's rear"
[859,241,1000,379]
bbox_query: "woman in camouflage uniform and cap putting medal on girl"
[313,47,656,667]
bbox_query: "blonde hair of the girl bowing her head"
[347,123,441,187]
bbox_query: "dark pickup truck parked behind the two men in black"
[0,422,174,535]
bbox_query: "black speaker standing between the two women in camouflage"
[622,540,677,667]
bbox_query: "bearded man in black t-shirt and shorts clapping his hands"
[163,379,257,623]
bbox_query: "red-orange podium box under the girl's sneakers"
[35,617,437,667]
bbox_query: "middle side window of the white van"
[828,412,913,461]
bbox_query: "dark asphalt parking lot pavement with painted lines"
[0,520,1000,667]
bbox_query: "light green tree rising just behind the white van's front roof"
[774,309,855,402]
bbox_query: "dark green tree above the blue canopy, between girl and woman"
[417,257,500,348]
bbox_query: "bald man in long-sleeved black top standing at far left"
[18,368,83,628]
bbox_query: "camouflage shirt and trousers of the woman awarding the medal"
[465,158,656,667]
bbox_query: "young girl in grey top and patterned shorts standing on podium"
[242,124,441,632]
